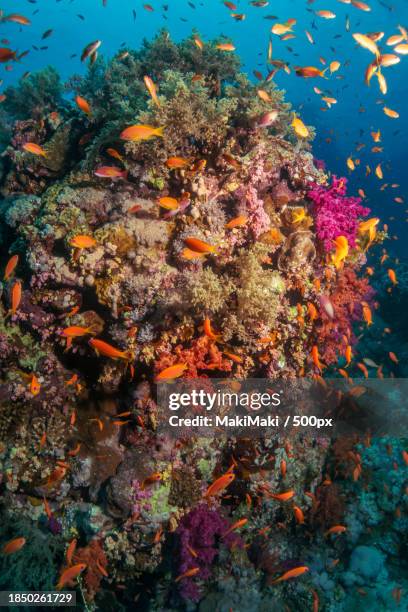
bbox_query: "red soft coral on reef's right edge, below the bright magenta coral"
[316,268,373,365]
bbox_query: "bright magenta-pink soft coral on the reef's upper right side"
[308,176,370,251]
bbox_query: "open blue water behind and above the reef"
[0,0,408,257]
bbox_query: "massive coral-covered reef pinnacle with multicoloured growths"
[0,32,394,610]
